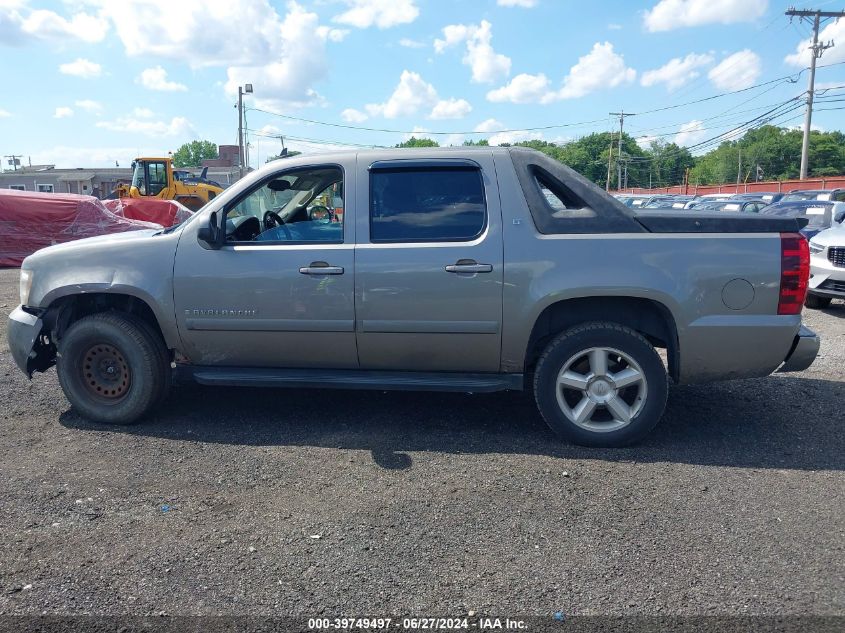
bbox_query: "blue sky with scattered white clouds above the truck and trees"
[0,0,845,167]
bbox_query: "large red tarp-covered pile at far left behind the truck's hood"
[0,189,165,266]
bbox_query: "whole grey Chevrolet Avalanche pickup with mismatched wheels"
[8,147,819,446]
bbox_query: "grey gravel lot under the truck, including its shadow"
[0,270,845,616]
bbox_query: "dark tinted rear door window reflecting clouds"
[370,167,487,242]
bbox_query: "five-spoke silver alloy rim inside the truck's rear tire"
[555,347,648,433]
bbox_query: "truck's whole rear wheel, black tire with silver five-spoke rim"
[534,322,668,447]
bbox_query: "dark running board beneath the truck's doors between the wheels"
[188,367,523,393]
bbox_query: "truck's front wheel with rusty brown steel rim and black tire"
[56,312,170,424]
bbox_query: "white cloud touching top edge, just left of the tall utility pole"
[644,0,769,33]
